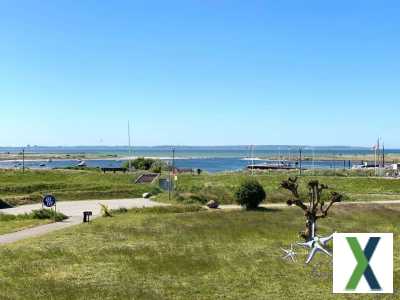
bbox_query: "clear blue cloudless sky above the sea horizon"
[0,0,400,147]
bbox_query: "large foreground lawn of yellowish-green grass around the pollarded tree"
[0,205,400,299]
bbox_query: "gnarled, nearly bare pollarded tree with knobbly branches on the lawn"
[281,177,343,241]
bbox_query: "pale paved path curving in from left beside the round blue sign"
[0,198,168,244]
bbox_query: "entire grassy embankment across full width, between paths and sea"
[0,170,400,209]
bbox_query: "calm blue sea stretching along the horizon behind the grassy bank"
[0,146,400,172]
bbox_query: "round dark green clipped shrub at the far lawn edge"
[235,179,266,209]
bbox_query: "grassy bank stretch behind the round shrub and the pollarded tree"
[168,172,400,203]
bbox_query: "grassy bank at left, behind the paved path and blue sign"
[0,170,159,205]
